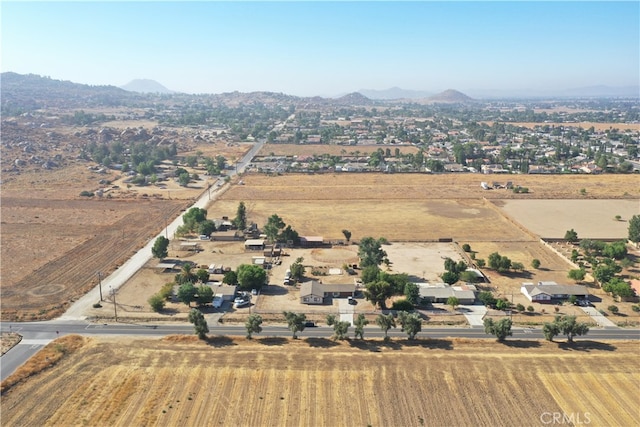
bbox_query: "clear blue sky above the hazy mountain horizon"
[0,1,640,96]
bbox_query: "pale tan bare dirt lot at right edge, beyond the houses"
[494,201,640,240]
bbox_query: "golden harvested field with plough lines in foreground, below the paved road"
[2,337,640,426]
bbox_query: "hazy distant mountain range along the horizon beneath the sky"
[0,72,640,113]
